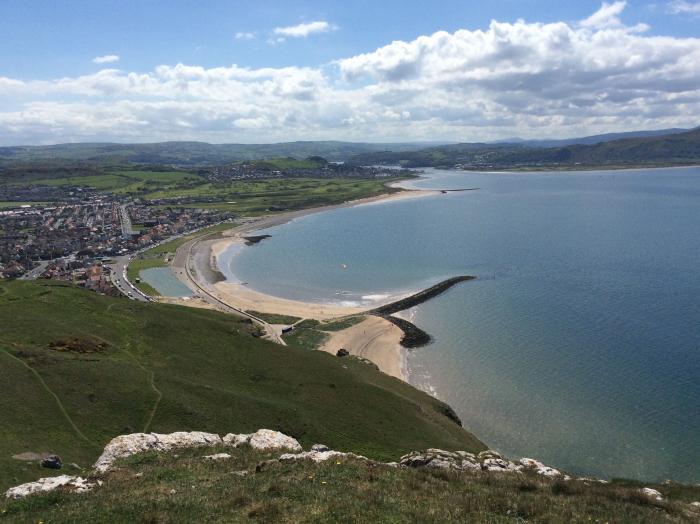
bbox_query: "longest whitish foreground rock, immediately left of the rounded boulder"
[94,431,222,473]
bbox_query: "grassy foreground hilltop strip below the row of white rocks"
[0,447,700,524]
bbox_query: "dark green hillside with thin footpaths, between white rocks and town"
[0,281,482,488]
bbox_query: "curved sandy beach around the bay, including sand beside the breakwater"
[173,181,441,382]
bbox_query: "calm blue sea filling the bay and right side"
[227,168,700,482]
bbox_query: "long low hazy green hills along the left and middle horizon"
[0,141,448,166]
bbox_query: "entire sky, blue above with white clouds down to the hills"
[0,0,700,145]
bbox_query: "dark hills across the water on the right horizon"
[348,128,700,169]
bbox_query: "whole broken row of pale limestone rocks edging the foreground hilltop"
[5,429,688,508]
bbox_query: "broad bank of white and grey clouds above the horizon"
[0,4,700,144]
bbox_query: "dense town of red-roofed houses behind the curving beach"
[0,197,232,284]
